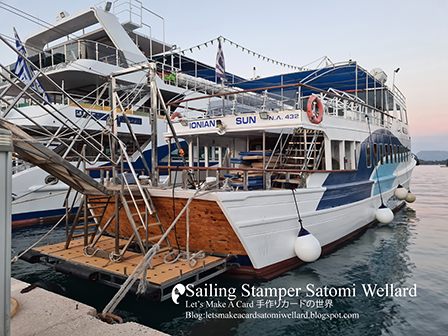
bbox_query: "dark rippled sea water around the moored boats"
[12,166,448,336]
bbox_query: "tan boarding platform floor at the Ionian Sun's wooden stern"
[32,237,228,300]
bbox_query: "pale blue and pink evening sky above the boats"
[0,0,448,153]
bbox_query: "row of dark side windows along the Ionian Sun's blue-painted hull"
[366,143,411,168]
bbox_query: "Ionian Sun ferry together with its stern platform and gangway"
[0,0,416,313]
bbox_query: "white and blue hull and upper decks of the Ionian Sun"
[142,61,416,278]
